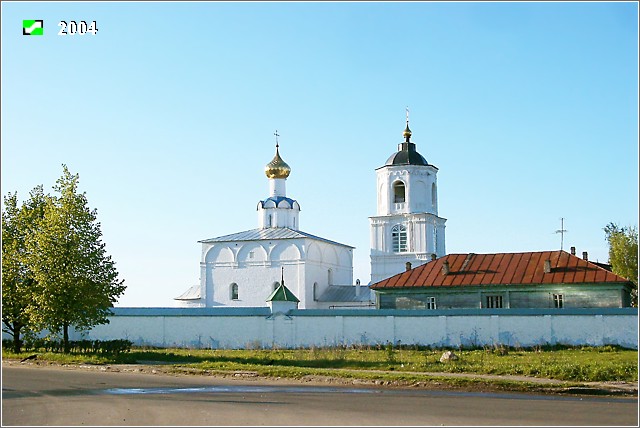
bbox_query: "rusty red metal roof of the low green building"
[370,251,629,290]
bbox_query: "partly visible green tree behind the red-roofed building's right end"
[604,223,638,306]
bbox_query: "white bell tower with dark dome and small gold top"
[369,114,446,283]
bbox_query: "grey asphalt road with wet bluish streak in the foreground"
[2,366,638,426]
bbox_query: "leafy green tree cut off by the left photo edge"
[2,186,45,353]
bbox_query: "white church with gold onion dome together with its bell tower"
[175,117,446,309]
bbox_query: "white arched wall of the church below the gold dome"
[195,238,353,309]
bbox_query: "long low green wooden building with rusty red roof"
[371,251,632,310]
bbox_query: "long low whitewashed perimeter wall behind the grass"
[67,308,638,349]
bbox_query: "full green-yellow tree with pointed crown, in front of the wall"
[27,165,125,352]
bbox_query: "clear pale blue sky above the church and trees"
[1,1,638,307]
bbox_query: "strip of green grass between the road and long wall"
[3,346,638,382]
